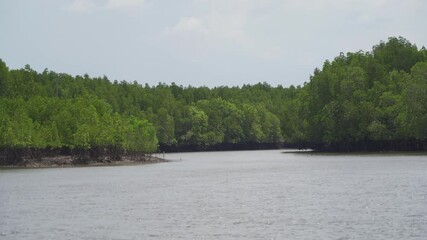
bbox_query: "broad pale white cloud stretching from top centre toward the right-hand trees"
[164,0,406,62]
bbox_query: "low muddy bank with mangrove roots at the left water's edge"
[0,155,168,168]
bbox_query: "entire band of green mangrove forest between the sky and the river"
[0,37,427,163]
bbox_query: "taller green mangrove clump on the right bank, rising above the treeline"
[306,38,427,148]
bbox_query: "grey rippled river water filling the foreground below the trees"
[0,150,427,240]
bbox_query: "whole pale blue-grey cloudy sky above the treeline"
[0,0,427,87]
